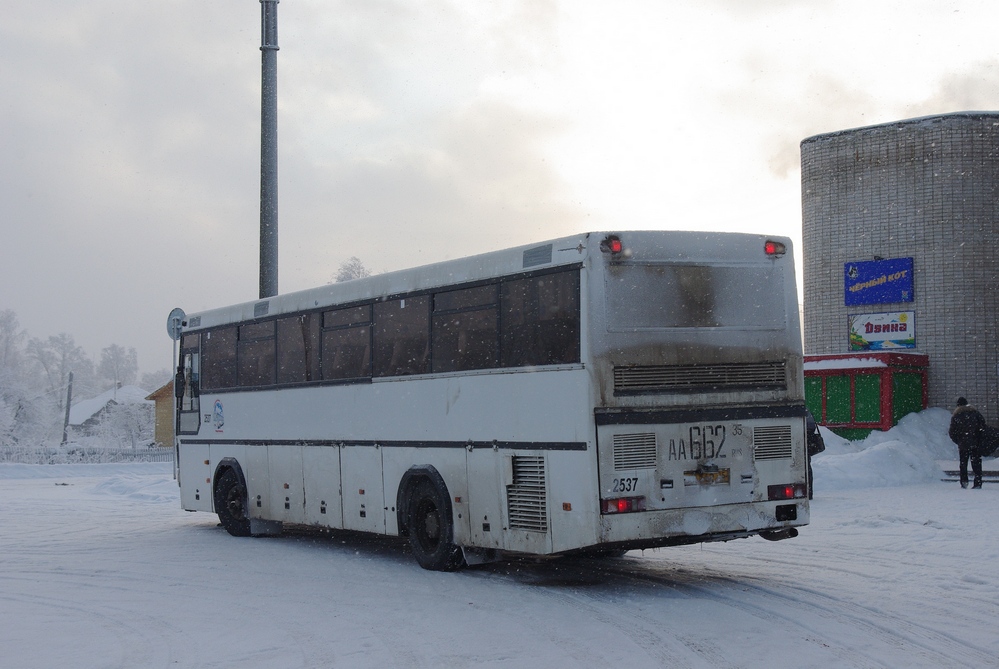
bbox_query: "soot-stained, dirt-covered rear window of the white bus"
[605,263,787,332]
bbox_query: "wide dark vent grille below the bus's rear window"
[614,360,787,394]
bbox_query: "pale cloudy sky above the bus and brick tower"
[0,0,999,371]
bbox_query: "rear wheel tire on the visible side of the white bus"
[406,477,465,571]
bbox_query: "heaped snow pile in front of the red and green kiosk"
[812,409,957,490]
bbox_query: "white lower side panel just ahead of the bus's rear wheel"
[340,444,385,534]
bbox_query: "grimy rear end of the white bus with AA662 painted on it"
[586,232,808,547]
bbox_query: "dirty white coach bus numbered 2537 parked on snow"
[175,231,809,570]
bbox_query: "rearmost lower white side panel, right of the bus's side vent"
[548,444,600,553]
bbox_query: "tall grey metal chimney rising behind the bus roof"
[260,0,280,298]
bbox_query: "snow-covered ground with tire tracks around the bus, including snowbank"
[0,409,999,669]
